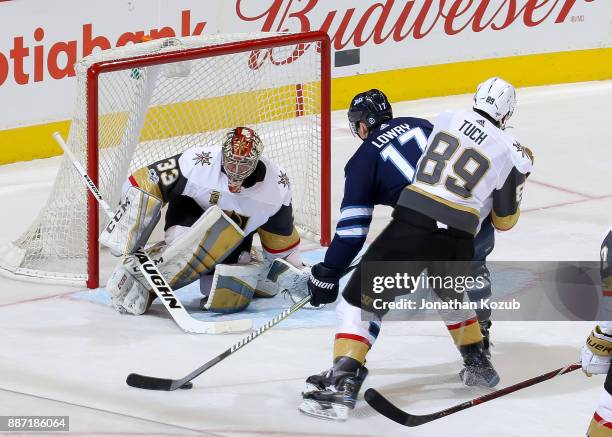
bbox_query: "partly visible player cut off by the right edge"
[581,229,612,437]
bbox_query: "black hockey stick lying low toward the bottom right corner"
[364,363,582,426]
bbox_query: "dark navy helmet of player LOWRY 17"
[348,89,393,135]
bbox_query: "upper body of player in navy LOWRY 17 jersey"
[320,89,432,276]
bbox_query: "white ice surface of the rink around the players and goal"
[0,81,612,437]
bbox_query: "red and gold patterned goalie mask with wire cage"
[222,127,263,193]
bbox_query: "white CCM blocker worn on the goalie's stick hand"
[100,186,162,255]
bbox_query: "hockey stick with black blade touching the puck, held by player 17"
[125,264,358,391]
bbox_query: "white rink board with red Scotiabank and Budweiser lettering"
[0,0,611,129]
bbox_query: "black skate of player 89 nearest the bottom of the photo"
[298,357,368,420]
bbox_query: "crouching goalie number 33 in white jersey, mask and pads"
[100,127,306,315]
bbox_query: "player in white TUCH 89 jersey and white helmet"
[305,78,533,416]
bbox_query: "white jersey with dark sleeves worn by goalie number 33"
[128,147,300,258]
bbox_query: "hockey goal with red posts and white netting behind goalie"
[0,31,331,288]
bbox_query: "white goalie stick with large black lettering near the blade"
[53,132,253,334]
